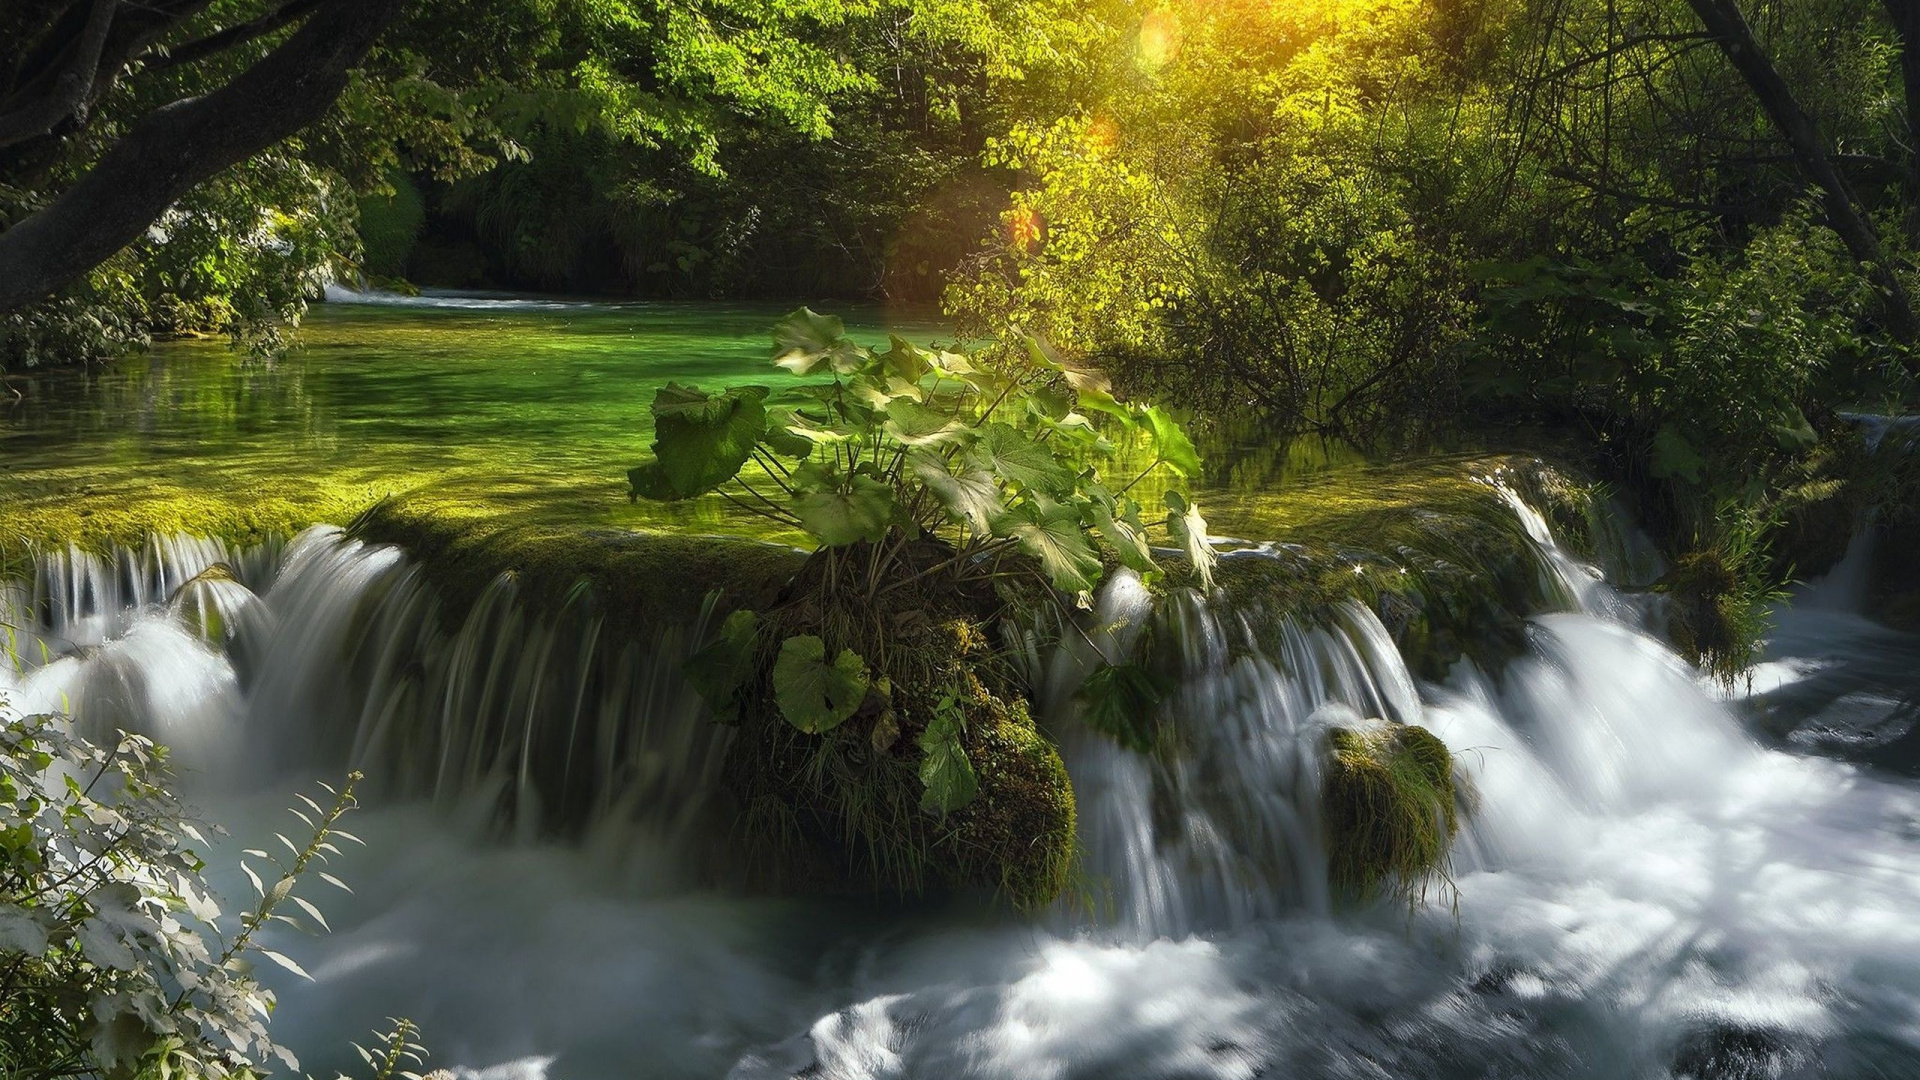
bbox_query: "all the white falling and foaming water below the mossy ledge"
[0,505,1920,1080]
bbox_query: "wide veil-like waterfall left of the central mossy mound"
[8,527,728,853]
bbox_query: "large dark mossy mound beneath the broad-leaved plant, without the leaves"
[726,555,1075,909]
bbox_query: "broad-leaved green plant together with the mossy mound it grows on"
[628,307,1213,907]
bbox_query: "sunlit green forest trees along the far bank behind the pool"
[0,0,1920,545]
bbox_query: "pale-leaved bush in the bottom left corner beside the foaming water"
[0,717,357,1080]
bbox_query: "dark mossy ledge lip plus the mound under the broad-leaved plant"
[349,500,1075,909]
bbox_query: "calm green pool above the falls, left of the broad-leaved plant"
[0,290,947,538]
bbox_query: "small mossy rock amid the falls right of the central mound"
[1321,721,1459,901]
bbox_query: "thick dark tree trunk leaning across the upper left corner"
[0,0,405,313]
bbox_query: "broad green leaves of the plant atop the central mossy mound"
[628,307,1213,600]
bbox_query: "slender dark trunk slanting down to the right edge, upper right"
[1688,0,1920,343]
